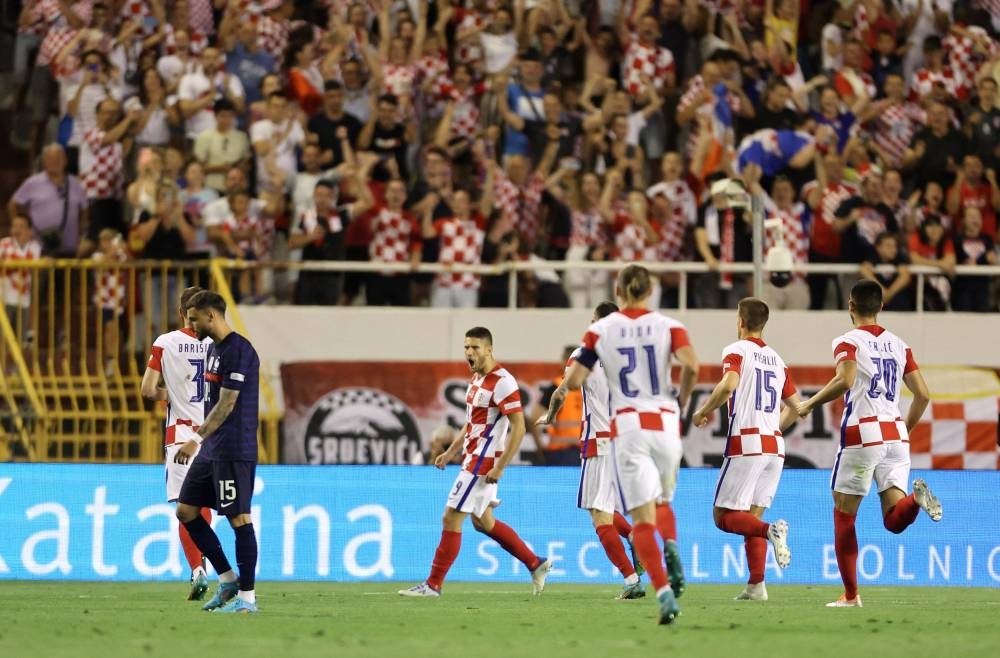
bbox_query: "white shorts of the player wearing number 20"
[830,441,910,496]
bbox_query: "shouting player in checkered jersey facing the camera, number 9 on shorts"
[399,327,552,597]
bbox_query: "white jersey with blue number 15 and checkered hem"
[722,337,795,457]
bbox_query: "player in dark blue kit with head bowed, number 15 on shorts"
[174,291,260,613]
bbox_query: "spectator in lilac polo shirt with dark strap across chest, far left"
[7,144,87,257]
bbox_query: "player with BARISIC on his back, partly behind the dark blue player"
[140,286,212,601]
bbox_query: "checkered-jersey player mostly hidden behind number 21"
[535,302,646,599]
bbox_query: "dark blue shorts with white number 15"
[177,456,257,516]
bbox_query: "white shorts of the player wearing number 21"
[611,423,683,511]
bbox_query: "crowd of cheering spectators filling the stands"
[0,0,1000,311]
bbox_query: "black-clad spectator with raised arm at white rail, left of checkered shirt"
[288,168,372,306]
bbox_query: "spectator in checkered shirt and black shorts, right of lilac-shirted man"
[80,98,139,255]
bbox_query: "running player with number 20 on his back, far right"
[798,280,941,608]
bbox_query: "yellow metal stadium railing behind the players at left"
[0,259,280,463]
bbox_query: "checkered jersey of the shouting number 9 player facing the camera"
[462,364,523,475]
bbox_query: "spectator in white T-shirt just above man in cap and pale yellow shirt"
[177,48,246,141]
